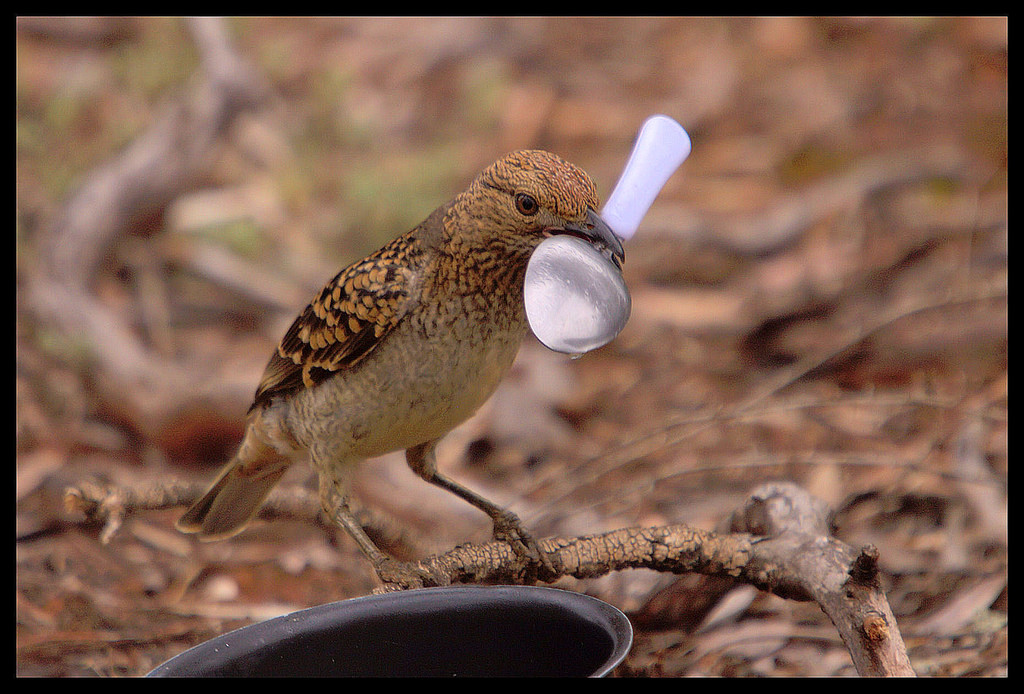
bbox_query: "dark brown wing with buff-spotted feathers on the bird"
[253,234,422,408]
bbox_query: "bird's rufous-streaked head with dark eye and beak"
[446,149,625,270]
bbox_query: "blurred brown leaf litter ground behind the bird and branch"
[15,17,1008,676]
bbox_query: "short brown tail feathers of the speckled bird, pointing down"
[176,441,291,540]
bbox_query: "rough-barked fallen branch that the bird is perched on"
[65,482,914,677]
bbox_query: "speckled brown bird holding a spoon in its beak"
[176,149,625,580]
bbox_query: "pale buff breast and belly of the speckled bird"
[289,284,526,461]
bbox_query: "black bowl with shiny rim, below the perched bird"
[150,585,633,677]
